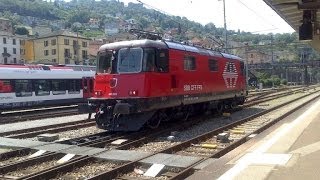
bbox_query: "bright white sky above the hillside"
[120,0,294,34]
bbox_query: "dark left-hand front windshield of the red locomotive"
[97,51,114,73]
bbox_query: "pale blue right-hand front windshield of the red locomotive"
[117,48,143,73]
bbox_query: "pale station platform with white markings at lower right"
[187,99,320,180]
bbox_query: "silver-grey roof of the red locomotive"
[99,39,242,60]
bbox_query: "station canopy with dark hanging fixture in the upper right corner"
[264,0,320,51]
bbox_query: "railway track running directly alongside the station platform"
[83,87,319,179]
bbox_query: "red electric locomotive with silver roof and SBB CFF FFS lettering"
[88,29,247,131]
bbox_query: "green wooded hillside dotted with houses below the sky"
[0,0,316,60]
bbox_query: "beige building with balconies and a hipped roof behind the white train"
[33,30,90,64]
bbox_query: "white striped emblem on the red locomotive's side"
[222,62,238,88]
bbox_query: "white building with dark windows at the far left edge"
[0,31,20,64]
